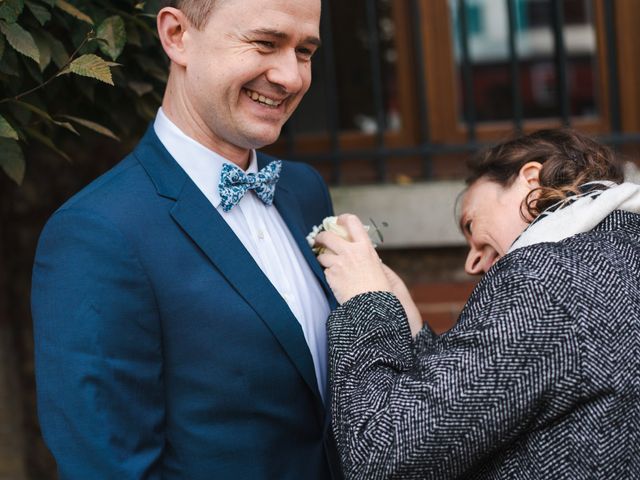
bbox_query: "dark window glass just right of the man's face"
[293,0,401,135]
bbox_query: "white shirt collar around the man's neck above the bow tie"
[153,107,258,208]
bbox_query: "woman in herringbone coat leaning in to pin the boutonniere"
[317,130,640,480]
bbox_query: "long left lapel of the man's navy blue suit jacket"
[135,127,322,415]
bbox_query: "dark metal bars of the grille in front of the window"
[284,0,640,183]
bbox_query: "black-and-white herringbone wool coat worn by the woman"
[328,211,640,480]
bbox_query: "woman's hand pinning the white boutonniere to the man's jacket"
[316,214,391,304]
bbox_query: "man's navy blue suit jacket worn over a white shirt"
[32,127,338,480]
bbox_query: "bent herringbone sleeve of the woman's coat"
[328,281,579,479]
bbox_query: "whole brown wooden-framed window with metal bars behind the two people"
[269,0,640,183]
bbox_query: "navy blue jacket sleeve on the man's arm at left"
[32,210,164,480]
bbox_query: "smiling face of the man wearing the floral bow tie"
[184,0,320,156]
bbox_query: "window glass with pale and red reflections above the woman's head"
[449,0,601,122]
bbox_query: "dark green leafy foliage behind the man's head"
[0,0,167,184]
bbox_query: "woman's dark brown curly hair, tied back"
[466,129,624,220]
